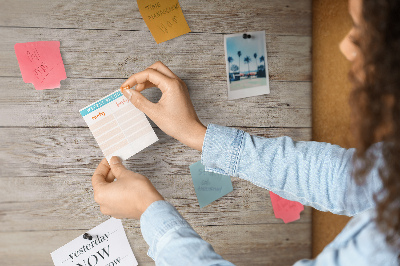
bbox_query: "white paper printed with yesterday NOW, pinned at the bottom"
[51,218,138,266]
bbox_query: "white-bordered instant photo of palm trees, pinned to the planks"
[224,31,269,100]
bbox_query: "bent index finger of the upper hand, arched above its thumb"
[121,68,172,92]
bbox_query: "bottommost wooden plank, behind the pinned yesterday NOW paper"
[0,223,311,266]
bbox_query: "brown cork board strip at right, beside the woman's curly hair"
[312,0,353,257]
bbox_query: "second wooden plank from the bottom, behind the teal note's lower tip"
[0,172,311,232]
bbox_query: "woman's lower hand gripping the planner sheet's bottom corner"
[92,156,164,219]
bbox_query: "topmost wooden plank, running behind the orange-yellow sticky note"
[0,0,311,36]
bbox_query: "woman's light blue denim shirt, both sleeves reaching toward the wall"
[140,124,398,266]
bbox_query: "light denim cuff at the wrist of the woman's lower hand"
[140,200,191,260]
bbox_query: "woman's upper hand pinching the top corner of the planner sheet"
[121,62,206,151]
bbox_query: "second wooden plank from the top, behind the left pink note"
[0,28,311,81]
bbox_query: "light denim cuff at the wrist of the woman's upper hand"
[201,124,244,176]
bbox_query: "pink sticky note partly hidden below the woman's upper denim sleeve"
[269,191,304,224]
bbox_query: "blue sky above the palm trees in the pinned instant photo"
[226,32,265,73]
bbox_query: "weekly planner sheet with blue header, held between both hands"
[79,90,158,161]
